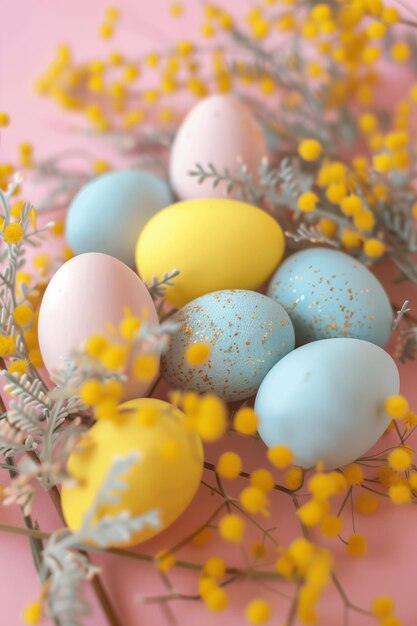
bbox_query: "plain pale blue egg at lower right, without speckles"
[255,339,400,469]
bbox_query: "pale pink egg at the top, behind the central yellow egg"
[169,94,267,200]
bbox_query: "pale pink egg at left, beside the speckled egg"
[38,252,158,399]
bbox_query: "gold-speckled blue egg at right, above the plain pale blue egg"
[268,248,393,346]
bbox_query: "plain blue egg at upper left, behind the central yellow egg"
[66,170,173,267]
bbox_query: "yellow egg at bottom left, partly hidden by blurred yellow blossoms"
[61,398,203,545]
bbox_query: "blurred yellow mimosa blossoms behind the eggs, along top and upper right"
[30,0,417,278]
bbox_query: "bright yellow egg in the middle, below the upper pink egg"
[136,198,285,307]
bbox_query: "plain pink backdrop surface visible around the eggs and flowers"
[0,0,417,626]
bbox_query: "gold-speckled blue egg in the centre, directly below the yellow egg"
[162,289,294,402]
